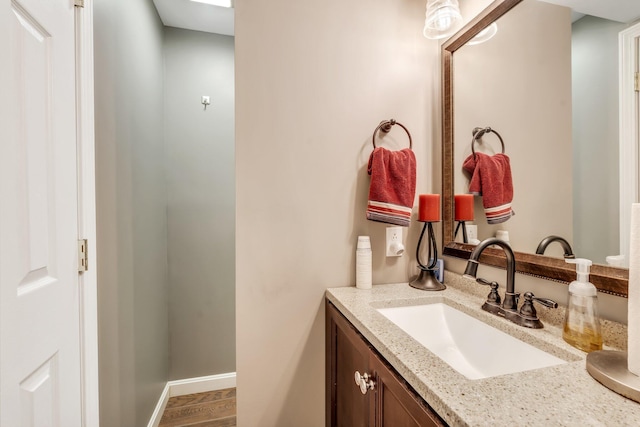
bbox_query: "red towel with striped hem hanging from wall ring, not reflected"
[367,147,416,227]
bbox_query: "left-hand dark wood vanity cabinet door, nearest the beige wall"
[326,303,374,427]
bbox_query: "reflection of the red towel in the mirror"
[462,153,515,224]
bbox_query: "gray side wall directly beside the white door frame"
[94,0,169,427]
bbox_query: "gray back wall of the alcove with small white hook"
[164,27,236,380]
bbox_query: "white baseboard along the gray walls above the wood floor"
[147,372,236,427]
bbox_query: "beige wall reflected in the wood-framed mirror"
[454,0,573,256]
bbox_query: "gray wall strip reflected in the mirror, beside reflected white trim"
[572,16,627,263]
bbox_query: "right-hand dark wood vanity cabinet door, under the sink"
[369,352,446,427]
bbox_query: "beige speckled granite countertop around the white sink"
[326,271,640,426]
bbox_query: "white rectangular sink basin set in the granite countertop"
[377,303,567,380]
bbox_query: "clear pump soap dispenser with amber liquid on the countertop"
[562,258,602,353]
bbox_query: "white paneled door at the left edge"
[0,0,82,427]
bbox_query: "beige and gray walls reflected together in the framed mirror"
[453,0,634,265]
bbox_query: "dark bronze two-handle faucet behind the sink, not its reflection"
[464,237,558,329]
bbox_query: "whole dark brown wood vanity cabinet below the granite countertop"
[326,301,446,427]
